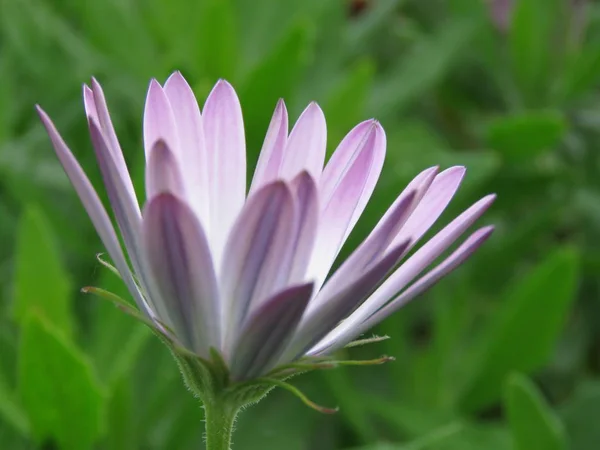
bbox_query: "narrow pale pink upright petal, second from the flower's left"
[83,78,139,209]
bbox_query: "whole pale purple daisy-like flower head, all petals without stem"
[38,72,494,380]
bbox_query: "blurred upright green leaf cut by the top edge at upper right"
[509,0,566,106]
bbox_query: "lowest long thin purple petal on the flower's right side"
[309,226,494,354]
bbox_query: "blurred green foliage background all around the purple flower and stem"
[0,0,600,450]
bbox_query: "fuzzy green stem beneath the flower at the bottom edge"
[204,397,238,450]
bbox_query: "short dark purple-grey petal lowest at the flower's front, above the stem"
[230,283,314,380]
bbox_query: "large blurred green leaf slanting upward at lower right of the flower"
[460,248,579,411]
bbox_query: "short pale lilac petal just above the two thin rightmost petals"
[392,166,466,248]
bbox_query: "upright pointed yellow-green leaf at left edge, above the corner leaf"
[13,207,73,336]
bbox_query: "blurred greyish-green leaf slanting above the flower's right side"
[368,18,479,117]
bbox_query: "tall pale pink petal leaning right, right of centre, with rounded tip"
[309,123,385,287]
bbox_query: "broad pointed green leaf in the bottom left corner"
[19,314,104,450]
